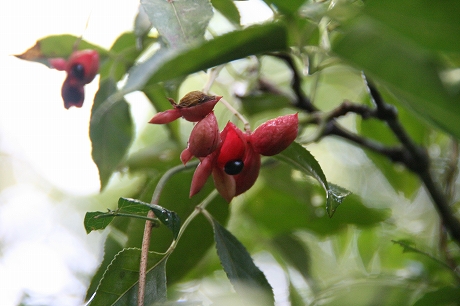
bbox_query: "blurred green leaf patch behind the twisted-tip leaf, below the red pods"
[242,164,391,236]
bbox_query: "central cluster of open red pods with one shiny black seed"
[150,91,299,202]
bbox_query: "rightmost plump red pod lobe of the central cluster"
[249,114,299,156]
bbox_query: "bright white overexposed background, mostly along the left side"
[0,0,271,306]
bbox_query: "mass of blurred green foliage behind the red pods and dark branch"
[18,0,460,305]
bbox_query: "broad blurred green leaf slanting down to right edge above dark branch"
[333,16,460,138]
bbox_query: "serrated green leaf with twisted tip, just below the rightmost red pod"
[275,142,350,217]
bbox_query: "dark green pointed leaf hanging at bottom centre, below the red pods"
[210,218,274,305]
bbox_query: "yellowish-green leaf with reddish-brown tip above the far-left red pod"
[15,34,107,68]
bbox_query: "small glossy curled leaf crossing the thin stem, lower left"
[118,198,181,239]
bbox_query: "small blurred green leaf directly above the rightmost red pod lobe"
[239,93,292,116]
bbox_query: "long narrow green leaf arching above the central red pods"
[123,23,287,93]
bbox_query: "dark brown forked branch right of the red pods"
[271,53,460,245]
